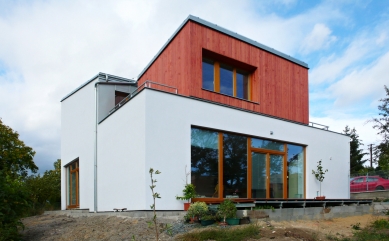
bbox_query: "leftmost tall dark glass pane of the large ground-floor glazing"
[191,128,219,198]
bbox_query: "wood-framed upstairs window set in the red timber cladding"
[202,58,250,100]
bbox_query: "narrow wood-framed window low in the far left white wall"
[67,159,80,208]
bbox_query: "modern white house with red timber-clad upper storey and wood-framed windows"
[61,16,349,211]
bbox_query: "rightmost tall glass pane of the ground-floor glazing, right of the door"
[287,144,304,198]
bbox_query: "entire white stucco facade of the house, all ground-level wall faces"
[61,84,349,211]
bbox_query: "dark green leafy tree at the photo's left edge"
[0,119,38,240]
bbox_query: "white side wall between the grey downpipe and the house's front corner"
[97,92,148,211]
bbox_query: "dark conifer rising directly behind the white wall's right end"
[343,126,367,173]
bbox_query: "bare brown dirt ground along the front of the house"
[22,214,382,241]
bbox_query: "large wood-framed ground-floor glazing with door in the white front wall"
[191,127,305,199]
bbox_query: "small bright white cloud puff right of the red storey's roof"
[300,23,336,54]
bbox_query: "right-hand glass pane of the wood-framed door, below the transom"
[269,154,284,198]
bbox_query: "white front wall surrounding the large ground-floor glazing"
[142,90,349,209]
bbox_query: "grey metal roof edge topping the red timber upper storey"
[138,15,309,79]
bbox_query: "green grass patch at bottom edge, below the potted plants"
[178,225,260,241]
